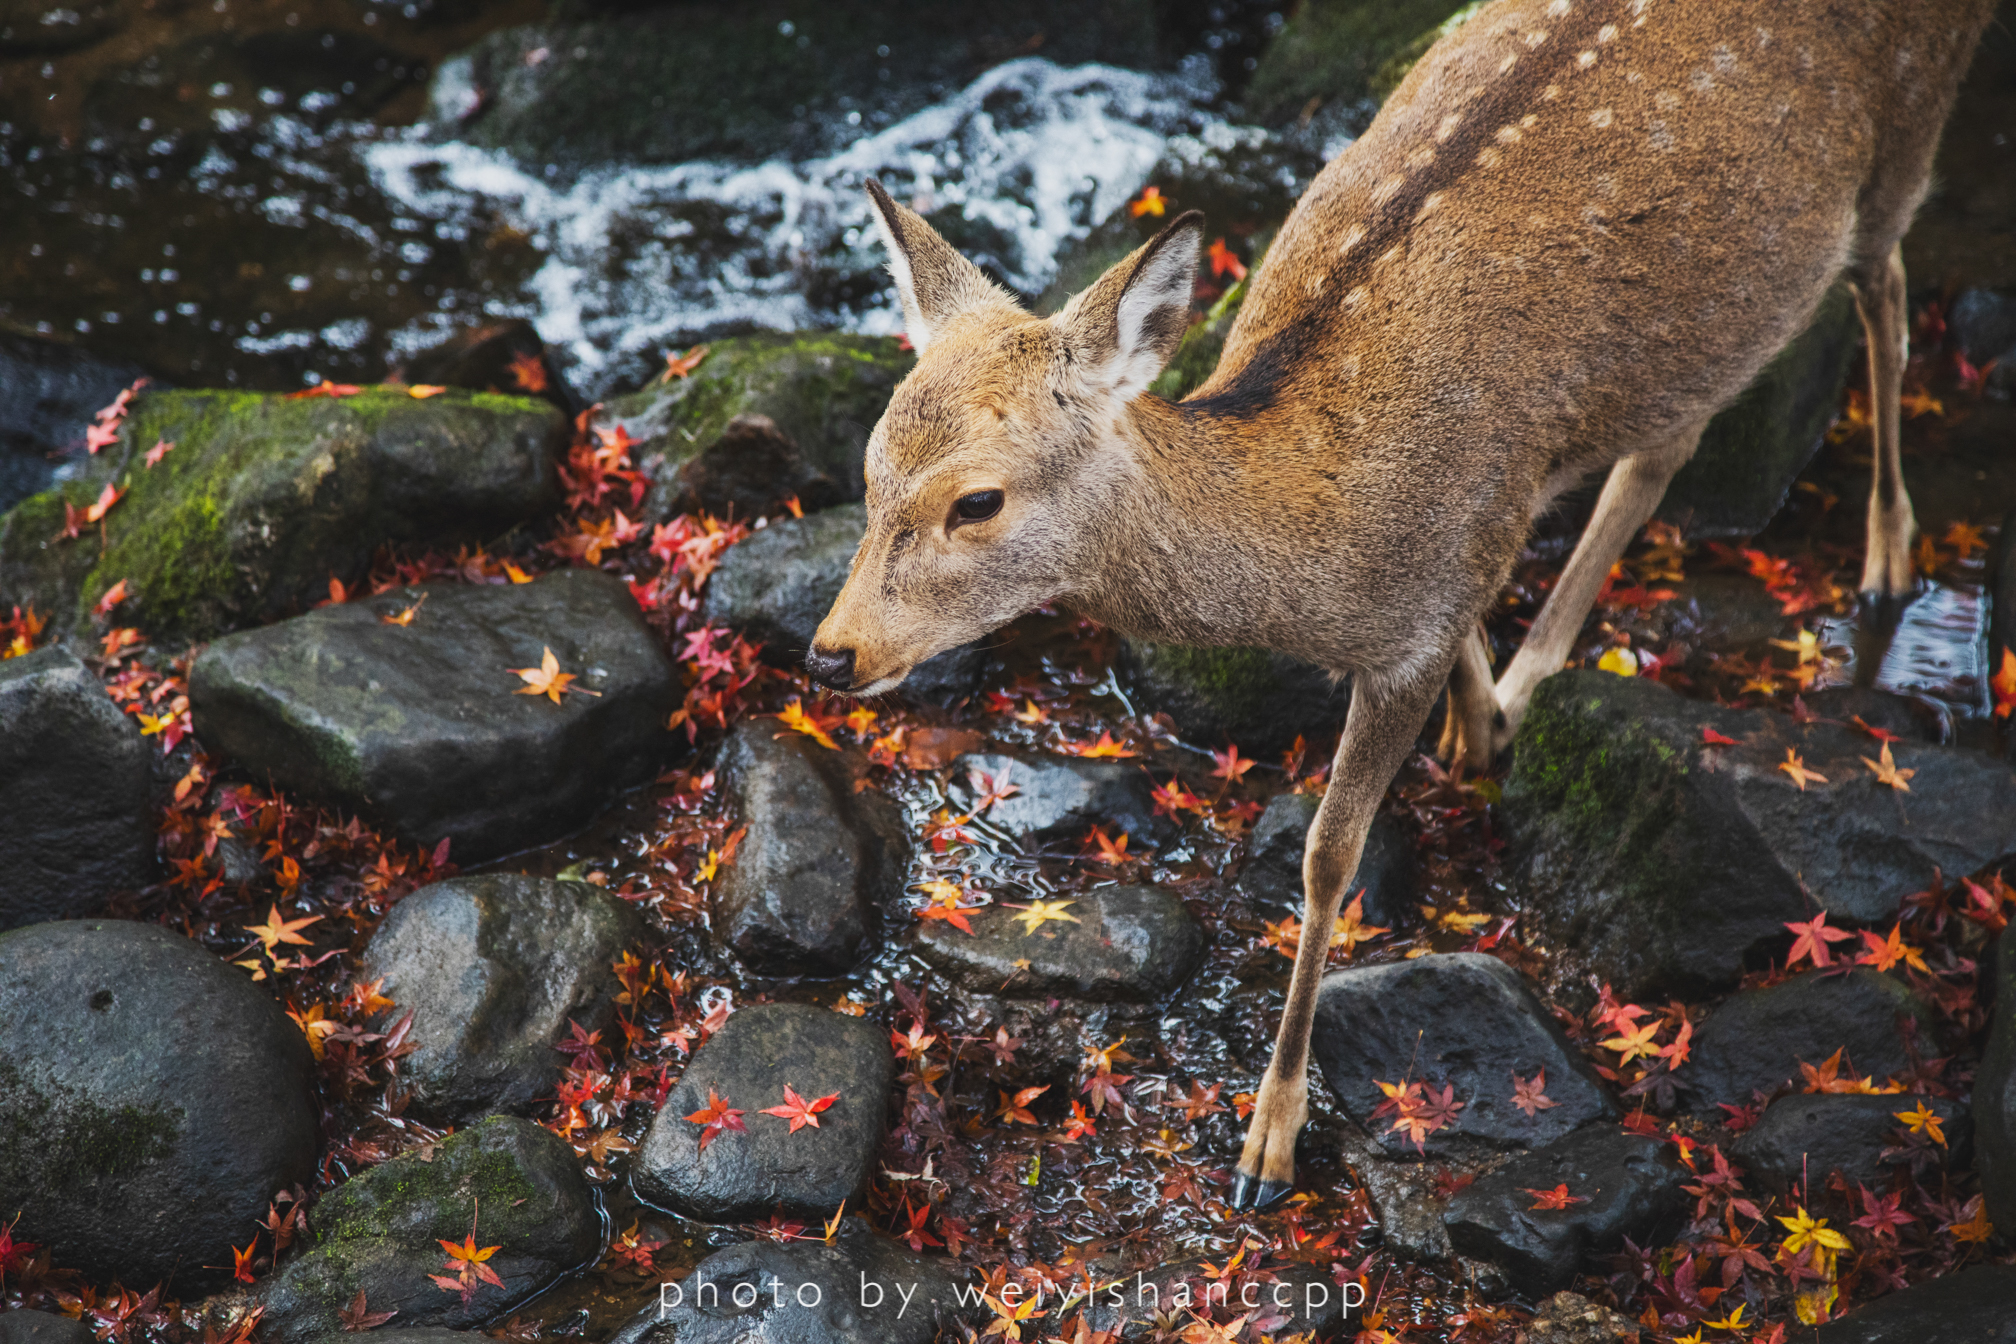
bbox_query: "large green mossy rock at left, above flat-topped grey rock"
[0,389,566,639]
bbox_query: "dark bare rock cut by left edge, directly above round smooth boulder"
[0,647,155,929]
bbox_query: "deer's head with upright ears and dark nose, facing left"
[804,181,1204,695]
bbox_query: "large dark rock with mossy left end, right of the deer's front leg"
[1504,671,2016,999]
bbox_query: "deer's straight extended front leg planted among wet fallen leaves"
[1232,668,1458,1209]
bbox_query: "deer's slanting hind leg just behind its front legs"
[1494,421,1708,750]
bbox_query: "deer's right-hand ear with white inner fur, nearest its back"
[1056,210,1204,401]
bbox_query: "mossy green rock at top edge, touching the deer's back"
[1246,0,1466,125]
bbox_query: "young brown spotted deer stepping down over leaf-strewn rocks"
[806,0,1992,1207]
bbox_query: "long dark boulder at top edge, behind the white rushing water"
[433,0,1157,167]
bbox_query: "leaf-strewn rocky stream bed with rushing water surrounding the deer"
[0,0,2016,1344]
